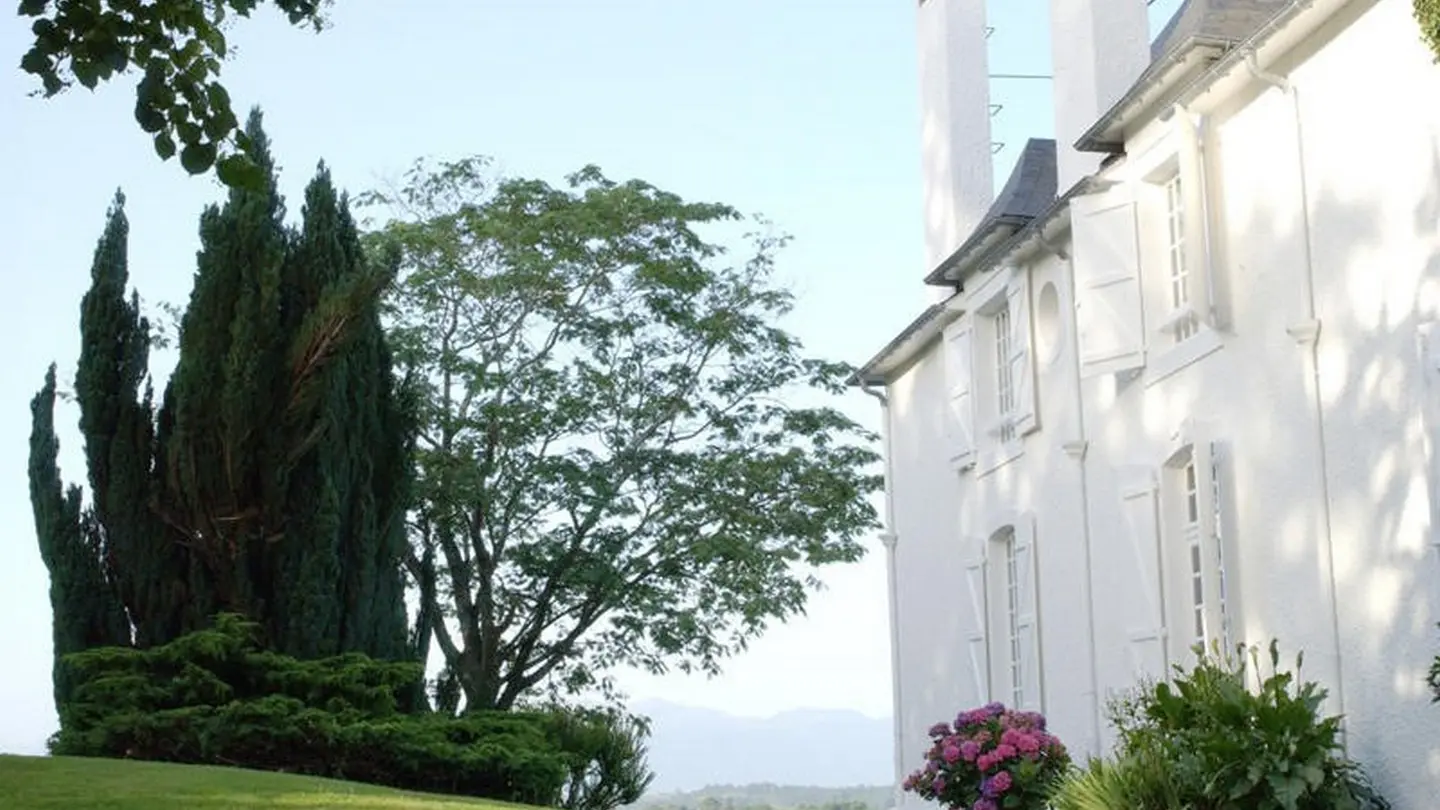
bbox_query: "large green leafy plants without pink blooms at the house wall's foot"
[1082,641,1388,810]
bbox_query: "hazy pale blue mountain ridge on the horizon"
[631,700,894,794]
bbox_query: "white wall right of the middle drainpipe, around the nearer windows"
[1083,0,1440,810]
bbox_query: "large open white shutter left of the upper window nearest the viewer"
[1070,187,1145,378]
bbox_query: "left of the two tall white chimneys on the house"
[919,0,996,298]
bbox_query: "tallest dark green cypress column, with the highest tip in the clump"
[158,112,288,624]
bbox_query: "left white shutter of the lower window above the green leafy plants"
[1120,477,1166,679]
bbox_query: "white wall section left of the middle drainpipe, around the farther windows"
[888,249,1096,807]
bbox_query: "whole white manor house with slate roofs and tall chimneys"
[854,0,1440,810]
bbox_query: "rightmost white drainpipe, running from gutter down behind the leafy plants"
[1246,49,1345,732]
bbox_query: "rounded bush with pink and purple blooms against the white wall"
[904,703,1070,810]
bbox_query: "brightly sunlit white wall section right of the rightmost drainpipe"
[1255,0,1440,795]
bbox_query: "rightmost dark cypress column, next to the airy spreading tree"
[276,164,409,659]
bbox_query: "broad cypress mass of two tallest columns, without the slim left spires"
[160,112,410,659]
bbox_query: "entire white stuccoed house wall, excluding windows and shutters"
[890,0,1440,810]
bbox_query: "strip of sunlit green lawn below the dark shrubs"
[0,755,535,810]
